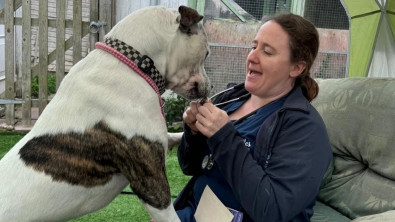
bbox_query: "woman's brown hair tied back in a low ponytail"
[262,13,320,101]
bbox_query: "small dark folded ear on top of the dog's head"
[178,5,203,35]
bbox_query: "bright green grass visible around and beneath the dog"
[0,131,189,222]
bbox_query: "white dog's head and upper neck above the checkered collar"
[106,6,211,99]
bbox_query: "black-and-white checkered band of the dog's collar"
[104,38,166,94]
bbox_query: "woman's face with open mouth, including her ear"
[245,21,305,98]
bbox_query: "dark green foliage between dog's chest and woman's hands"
[164,93,189,132]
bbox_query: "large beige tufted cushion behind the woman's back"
[312,78,395,221]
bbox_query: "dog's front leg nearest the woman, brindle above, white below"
[118,137,180,222]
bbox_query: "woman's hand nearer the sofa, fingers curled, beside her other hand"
[196,102,230,138]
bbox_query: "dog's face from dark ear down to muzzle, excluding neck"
[166,6,211,99]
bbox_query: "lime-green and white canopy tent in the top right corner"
[341,0,395,77]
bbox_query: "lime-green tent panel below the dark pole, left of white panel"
[348,13,380,77]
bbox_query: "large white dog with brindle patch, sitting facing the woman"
[0,6,210,222]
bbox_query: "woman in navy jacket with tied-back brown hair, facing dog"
[175,14,332,222]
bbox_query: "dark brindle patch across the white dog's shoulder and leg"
[19,122,171,209]
